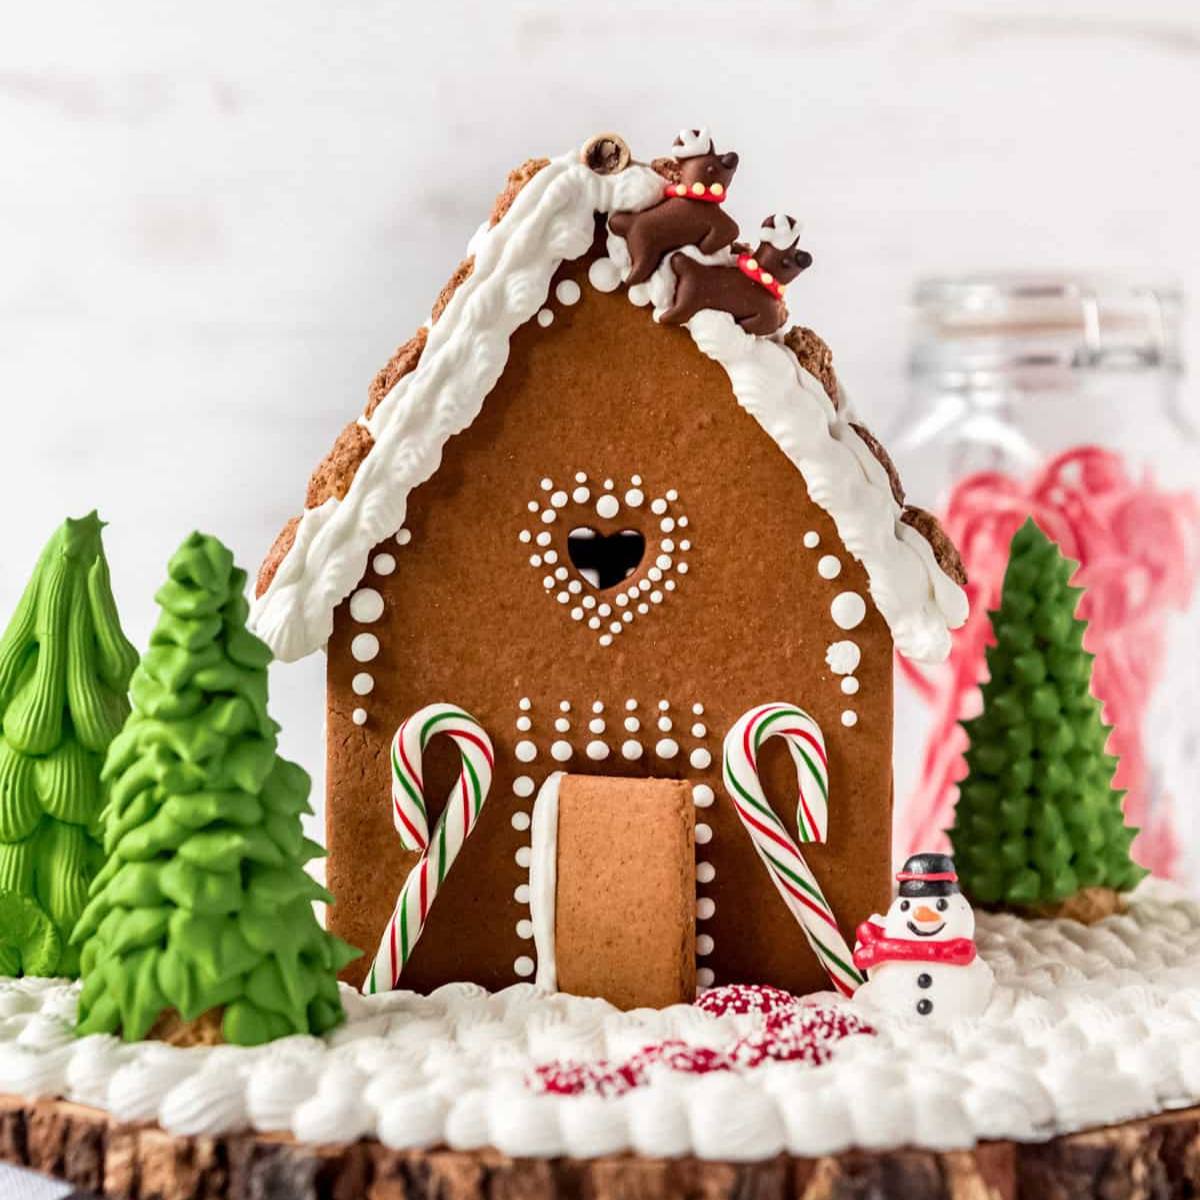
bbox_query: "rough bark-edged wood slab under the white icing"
[0,1096,1200,1200]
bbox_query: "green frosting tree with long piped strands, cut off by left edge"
[0,512,138,976]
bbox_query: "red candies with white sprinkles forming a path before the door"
[526,984,875,1096]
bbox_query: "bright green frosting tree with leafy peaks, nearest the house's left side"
[74,533,358,1045]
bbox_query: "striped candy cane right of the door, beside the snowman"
[724,703,863,996]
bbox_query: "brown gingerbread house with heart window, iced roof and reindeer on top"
[253,131,966,1007]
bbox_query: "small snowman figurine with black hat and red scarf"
[854,854,995,1025]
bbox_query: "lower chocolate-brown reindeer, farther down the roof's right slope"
[660,214,812,337]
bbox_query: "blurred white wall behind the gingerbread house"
[0,0,1200,844]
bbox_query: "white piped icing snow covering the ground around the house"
[0,883,1200,1159]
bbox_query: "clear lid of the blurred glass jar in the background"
[910,271,1182,386]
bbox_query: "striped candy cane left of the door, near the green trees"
[362,704,494,994]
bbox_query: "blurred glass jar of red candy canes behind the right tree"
[887,274,1200,884]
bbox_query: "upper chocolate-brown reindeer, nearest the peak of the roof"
[608,130,738,284]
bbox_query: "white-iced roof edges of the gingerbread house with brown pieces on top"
[252,136,967,661]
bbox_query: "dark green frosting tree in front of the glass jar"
[949,518,1146,907]
